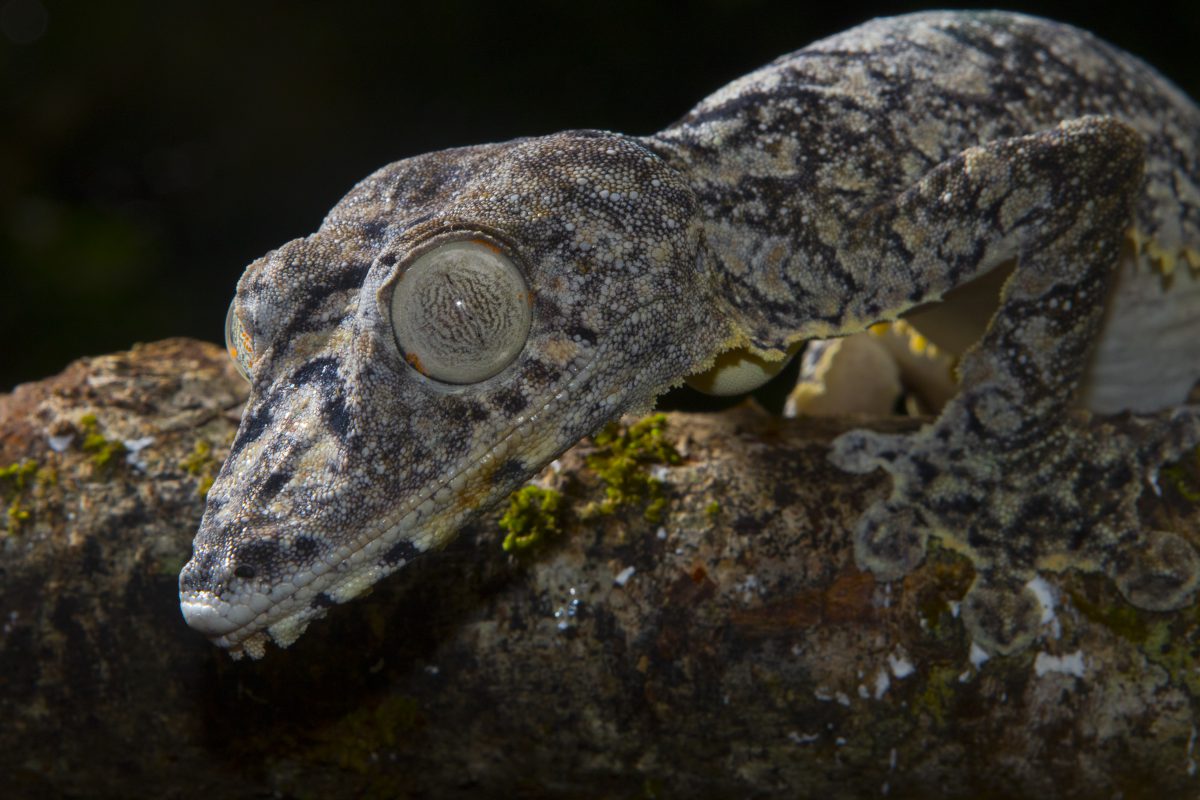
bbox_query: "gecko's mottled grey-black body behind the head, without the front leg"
[647,12,1200,413]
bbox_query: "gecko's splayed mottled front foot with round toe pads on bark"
[830,403,1200,654]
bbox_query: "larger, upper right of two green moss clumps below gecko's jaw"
[583,414,683,523]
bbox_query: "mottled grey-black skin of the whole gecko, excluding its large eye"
[180,12,1200,656]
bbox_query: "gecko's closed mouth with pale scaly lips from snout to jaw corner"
[180,300,664,658]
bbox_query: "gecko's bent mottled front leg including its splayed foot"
[833,118,1200,652]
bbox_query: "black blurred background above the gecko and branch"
[0,0,1200,391]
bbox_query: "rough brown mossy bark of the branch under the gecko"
[0,339,1200,798]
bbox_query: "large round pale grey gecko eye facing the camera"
[391,240,530,384]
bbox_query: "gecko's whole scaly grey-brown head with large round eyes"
[180,132,728,656]
